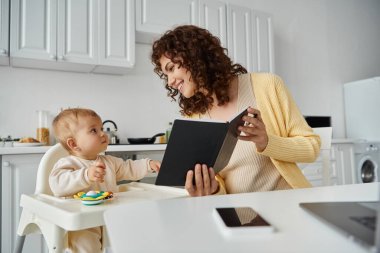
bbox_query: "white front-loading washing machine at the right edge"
[354,142,380,183]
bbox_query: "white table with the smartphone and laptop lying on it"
[104,183,380,253]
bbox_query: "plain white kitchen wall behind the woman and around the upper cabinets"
[0,0,380,142]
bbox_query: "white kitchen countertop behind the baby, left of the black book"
[0,144,166,155]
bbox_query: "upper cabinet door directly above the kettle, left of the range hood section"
[98,0,135,67]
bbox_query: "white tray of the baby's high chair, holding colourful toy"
[20,182,188,231]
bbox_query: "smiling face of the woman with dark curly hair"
[160,55,197,98]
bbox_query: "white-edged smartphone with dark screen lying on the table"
[214,207,275,236]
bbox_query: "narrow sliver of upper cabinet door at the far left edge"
[0,0,9,65]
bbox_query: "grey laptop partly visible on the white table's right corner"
[300,202,380,252]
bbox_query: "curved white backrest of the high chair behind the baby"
[34,143,69,195]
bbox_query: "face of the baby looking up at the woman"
[75,116,108,159]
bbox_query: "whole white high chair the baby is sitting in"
[14,144,188,253]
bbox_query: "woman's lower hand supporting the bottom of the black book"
[185,164,219,197]
